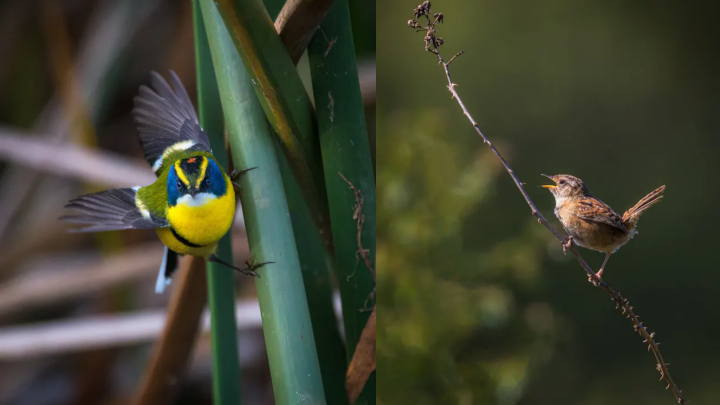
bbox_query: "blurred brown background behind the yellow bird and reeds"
[0,0,375,405]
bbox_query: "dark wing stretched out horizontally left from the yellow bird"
[60,188,170,232]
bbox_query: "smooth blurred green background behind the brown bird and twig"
[377,0,720,405]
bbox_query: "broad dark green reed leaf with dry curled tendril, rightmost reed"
[308,0,375,404]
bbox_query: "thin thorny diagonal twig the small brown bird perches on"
[408,1,686,404]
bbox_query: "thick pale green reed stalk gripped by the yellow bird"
[200,0,325,405]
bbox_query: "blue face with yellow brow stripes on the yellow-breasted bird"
[167,156,227,207]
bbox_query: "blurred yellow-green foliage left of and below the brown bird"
[377,111,558,404]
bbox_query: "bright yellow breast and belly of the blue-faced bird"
[157,178,235,256]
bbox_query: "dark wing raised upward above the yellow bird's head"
[132,71,210,173]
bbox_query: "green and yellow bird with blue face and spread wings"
[61,71,269,294]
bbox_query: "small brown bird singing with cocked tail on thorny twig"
[542,174,665,278]
